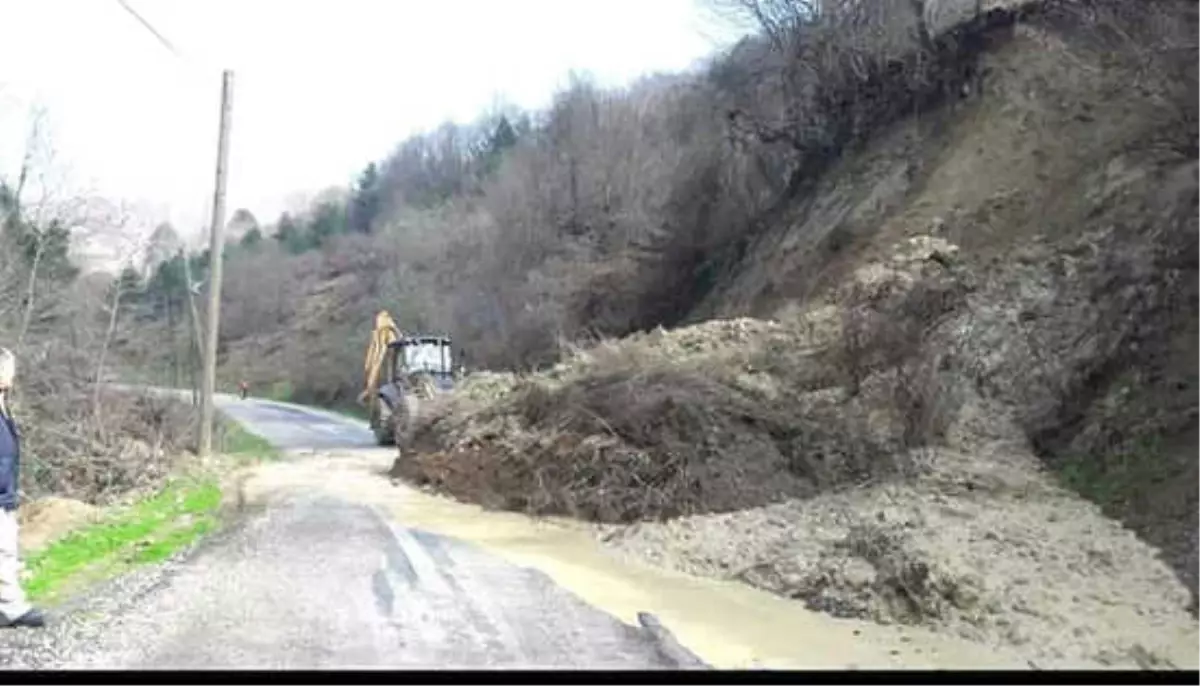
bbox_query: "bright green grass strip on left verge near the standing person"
[25,477,221,602]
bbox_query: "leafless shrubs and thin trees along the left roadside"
[0,124,200,504]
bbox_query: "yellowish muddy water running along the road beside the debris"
[234,451,1030,669]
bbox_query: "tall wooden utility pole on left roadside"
[199,70,233,457]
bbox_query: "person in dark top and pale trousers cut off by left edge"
[0,348,46,627]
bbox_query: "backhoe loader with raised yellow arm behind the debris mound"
[359,311,455,450]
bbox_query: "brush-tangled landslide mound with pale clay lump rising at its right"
[396,236,961,522]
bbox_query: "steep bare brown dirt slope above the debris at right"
[697,2,1200,599]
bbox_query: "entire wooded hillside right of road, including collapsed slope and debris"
[124,0,1200,667]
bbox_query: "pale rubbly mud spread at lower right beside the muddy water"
[607,460,1200,668]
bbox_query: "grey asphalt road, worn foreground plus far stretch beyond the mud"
[0,397,698,669]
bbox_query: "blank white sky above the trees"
[0,0,734,249]
